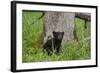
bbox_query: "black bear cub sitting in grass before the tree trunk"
[43,31,64,55]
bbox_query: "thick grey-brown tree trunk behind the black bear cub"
[44,12,75,45]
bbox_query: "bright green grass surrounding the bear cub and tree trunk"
[22,11,91,63]
